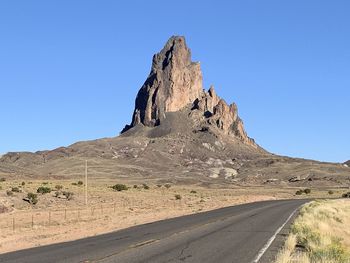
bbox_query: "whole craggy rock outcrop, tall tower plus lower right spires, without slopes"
[122,36,257,150]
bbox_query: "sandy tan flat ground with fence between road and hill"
[0,179,341,253]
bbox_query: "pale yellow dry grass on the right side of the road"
[276,199,350,263]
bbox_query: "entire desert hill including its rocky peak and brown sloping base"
[0,36,350,186]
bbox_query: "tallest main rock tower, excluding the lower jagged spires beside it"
[126,36,203,129]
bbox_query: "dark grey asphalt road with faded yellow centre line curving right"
[0,200,307,263]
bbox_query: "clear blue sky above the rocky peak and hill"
[0,0,350,162]
